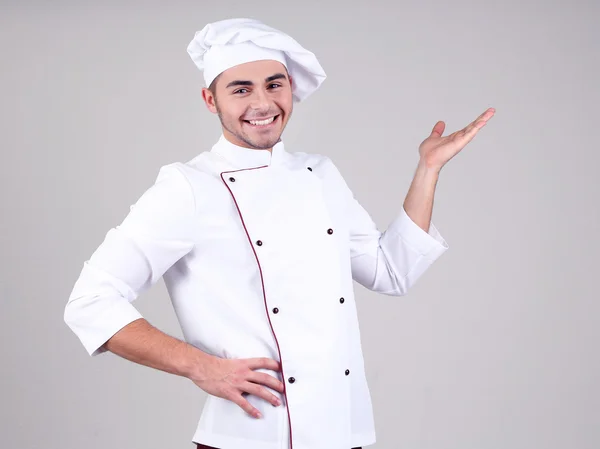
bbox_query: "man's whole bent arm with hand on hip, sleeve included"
[64,164,284,417]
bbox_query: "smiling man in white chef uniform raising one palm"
[65,19,494,449]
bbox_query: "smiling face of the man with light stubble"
[202,60,293,150]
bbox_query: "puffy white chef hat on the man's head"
[187,19,326,102]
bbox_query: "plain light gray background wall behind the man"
[0,0,600,449]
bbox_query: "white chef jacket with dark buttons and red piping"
[64,136,448,449]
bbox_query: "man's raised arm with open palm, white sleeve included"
[339,108,496,296]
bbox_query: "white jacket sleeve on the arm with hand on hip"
[64,164,198,356]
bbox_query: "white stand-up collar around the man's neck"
[211,134,286,169]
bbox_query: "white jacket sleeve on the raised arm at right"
[326,156,448,296]
